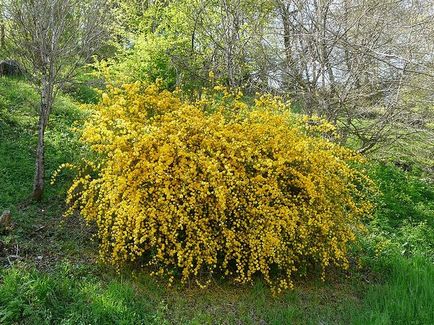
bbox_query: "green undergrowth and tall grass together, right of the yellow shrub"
[353,162,434,324]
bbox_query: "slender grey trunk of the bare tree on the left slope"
[32,78,53,201]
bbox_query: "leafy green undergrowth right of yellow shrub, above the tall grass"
[357,163,434,264]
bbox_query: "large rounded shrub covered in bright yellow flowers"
[68,83,371,288]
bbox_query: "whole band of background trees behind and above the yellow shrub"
[96,0,434,167]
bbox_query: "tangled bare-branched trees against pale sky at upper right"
[274,0,434,152]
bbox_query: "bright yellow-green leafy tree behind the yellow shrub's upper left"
[94,0,189,89]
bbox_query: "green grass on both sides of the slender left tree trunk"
[0,77,84,205]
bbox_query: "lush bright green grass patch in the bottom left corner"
[0,263,160,324]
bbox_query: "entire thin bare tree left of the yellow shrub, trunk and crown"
[5,0,110,200]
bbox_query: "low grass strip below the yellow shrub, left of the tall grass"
[0,263,356,324]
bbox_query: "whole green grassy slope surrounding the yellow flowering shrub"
[0,78,434,324]
